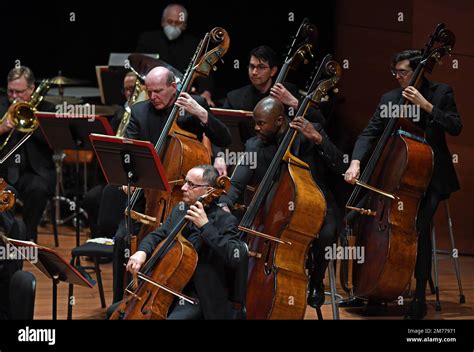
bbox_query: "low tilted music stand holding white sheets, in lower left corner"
[8,238,94,320]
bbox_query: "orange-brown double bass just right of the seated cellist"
[239,55,342,319]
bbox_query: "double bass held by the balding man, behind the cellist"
[126,27,230,245]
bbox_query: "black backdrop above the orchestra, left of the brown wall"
[0,1,335,97]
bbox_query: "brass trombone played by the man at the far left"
[0,79,51,164]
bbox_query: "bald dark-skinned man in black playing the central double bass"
[220,97,345,307]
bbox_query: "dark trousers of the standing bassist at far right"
[415,187,446,301]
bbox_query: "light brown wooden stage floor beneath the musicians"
[24,227,474,320]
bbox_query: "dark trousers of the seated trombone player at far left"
[13,170,55,241]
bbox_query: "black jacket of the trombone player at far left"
[0,98,56,184]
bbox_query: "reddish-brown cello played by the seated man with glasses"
[110,176,230,320]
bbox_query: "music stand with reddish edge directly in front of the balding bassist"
[89,134,171,243]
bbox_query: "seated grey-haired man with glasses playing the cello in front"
[108,165,245,320]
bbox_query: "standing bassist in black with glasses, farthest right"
[344,50,462,319]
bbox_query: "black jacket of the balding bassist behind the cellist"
[125,95,232,147]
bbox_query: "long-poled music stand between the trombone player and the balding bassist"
[35,113,113,246]
